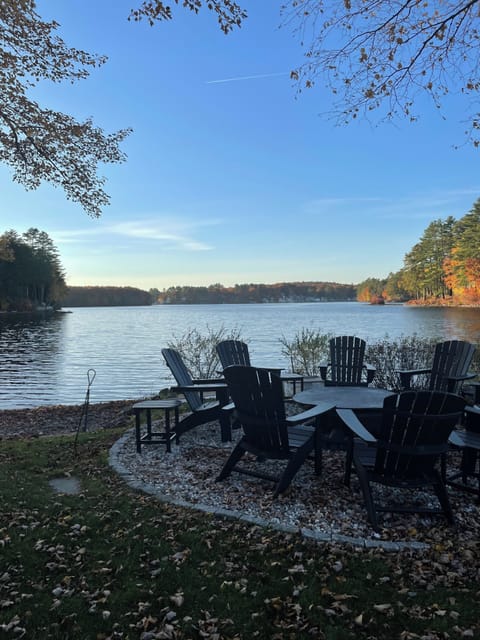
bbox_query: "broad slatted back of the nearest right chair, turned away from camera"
[374,391,465,480]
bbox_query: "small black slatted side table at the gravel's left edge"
[133,399,182,453]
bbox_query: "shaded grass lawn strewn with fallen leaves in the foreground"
[0,430,480,640]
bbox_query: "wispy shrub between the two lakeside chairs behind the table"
[279,328,333,376]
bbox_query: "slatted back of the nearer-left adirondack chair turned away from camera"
[224,365,289,457]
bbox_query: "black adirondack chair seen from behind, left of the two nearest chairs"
[217,365,333,497]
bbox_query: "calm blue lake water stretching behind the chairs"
[0,302,480,409]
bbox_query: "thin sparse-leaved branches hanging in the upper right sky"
[283,0,480,147]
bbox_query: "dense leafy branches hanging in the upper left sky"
[0,0,129,217]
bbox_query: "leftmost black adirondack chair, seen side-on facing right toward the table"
[162,349,232,442]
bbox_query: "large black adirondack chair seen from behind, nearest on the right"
[337,391,465,531]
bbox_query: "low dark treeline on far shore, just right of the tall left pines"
[62,287,152,307]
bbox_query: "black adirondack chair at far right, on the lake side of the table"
[397,340,476,393]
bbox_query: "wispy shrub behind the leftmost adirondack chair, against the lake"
[167,325,244,378]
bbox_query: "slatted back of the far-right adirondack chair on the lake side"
[429,340,475,393]
